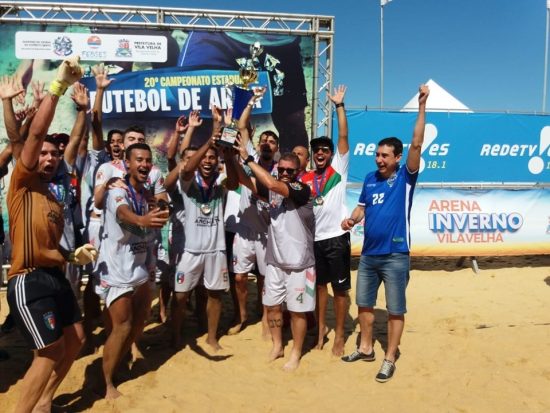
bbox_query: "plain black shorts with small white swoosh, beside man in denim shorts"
[313,232,351,291]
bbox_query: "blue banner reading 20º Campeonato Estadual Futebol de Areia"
[82,67,272,120]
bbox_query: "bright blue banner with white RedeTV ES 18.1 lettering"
[348,111,550,183]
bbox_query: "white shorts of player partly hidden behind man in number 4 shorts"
[232,233,267,275]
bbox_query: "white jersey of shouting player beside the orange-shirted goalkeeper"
[94,188,157,287]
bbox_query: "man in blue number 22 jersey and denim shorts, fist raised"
[342,85,430,383]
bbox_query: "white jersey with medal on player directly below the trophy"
[180,172,225,253]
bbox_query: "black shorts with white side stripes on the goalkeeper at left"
[8,268,82,349]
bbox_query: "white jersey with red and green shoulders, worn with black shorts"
[301,150,349,241]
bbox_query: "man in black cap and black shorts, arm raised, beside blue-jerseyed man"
[300,86,351,356]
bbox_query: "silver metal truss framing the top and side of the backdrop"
[0,1,334,138]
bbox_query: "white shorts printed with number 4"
[262,265,315,313]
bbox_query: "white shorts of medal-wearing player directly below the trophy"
[174,251,229,293]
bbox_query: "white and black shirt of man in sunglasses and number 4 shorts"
[265,182,315,270]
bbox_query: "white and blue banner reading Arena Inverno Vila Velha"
[348,186,550,256]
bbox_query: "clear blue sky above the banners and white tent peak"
[59,0,550,112]
